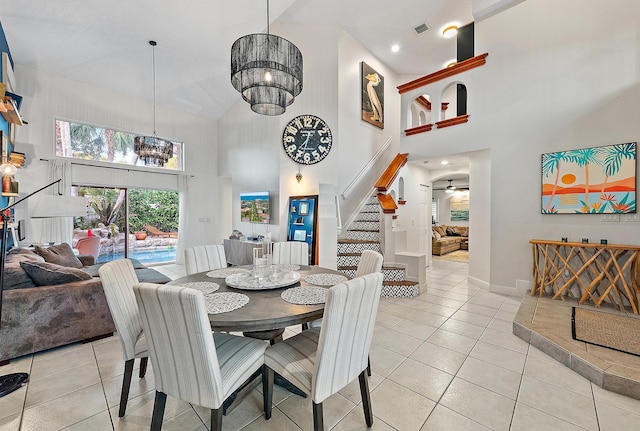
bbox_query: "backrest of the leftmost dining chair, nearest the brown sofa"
[98,259,142,361]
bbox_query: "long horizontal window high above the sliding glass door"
[56,120,183,171]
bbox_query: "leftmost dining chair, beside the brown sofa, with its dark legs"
[98,259,149,417]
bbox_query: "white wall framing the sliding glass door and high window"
[10,64,222,250]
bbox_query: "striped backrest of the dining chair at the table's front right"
[311,272,383,403]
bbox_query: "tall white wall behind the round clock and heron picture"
[218,24,400,248]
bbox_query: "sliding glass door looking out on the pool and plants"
[73,186,179,265]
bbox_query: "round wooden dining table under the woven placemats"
[168,265,348,340]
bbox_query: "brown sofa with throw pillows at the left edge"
[0,244,170,364]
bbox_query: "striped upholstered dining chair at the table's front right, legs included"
[264,272,383,431]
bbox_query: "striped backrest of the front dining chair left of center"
[133,283,224,408]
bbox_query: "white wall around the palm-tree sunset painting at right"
[402,0,640,291]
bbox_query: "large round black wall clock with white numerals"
[282,114,333,165]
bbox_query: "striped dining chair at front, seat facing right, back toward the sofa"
[134,283,267,431]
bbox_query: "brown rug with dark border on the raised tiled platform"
[571,307,640,356]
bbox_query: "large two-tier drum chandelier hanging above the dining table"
[231,0,302,115]
